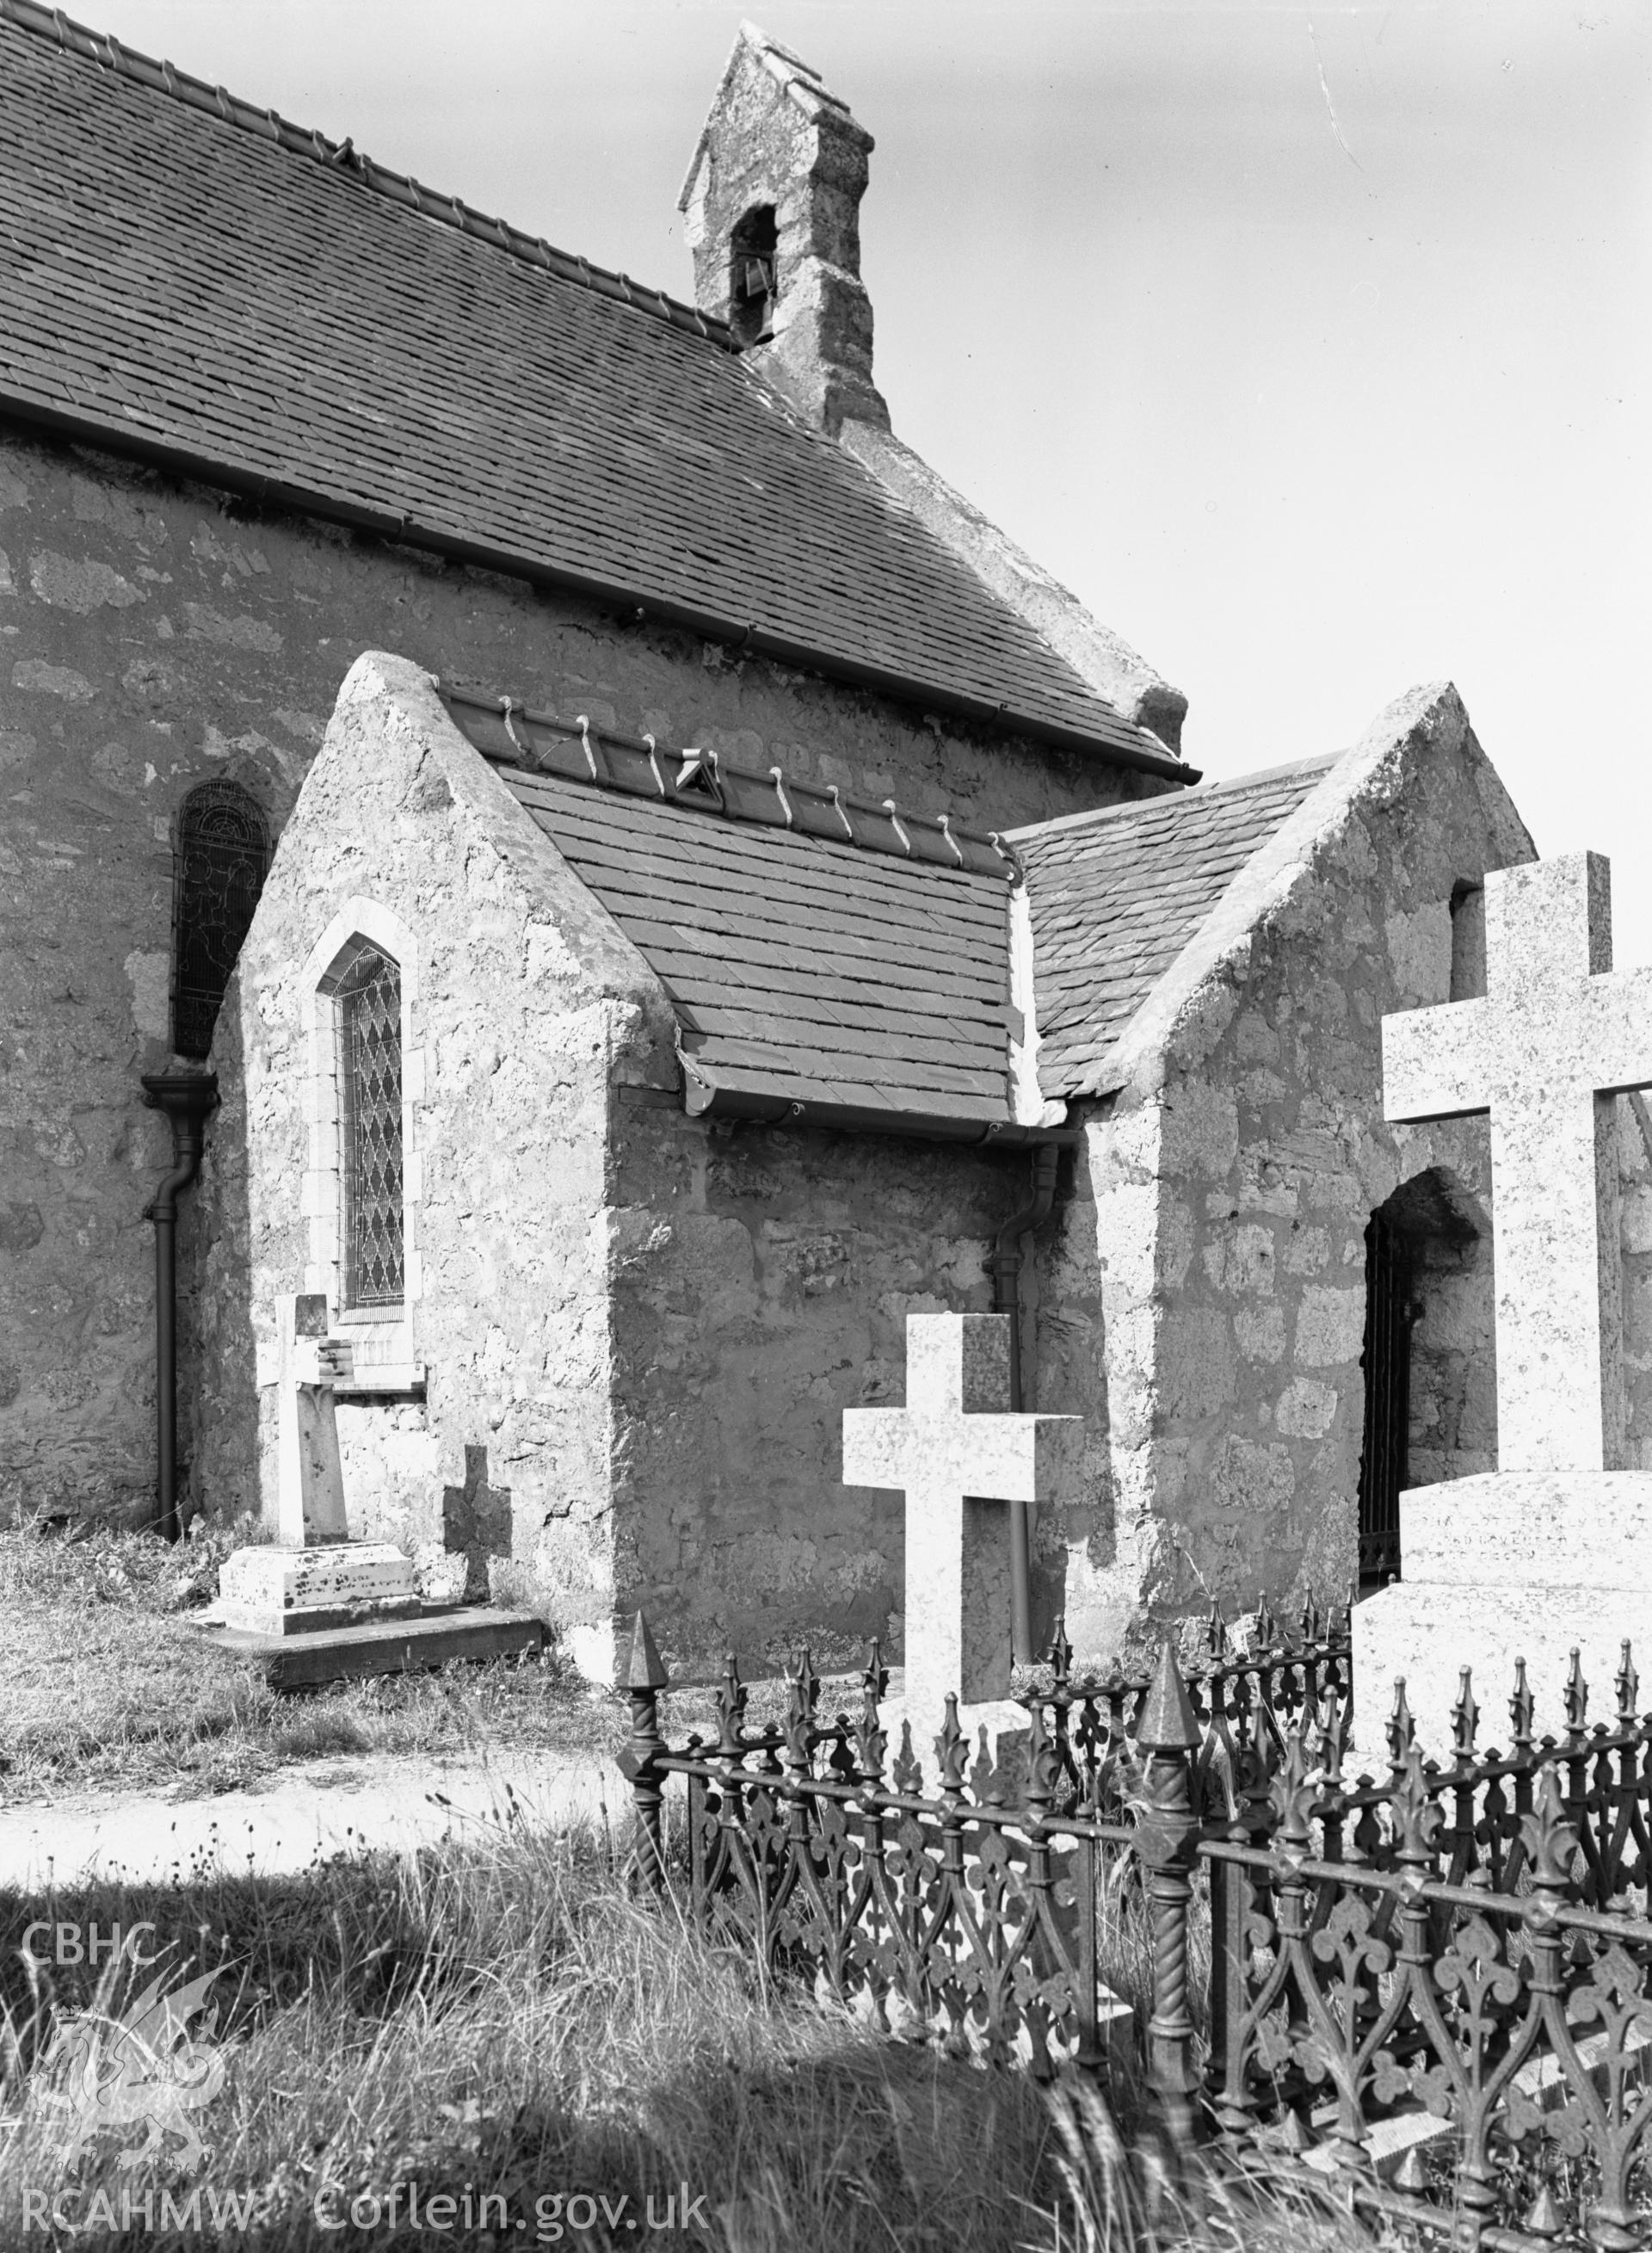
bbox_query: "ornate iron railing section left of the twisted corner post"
[625,1625,1136,2073]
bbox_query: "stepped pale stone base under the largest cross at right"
[1354,1472,1652,1764]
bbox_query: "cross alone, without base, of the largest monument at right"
[1382,854,1652,1472]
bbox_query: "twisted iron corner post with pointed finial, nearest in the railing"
[1136,1643,1199,2150]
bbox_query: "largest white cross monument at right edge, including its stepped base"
[1354,854,1652,1757]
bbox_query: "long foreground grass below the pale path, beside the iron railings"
[0,1827,1371,2253]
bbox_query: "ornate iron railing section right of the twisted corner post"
[1194,1676,1652,2246]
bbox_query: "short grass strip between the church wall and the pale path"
[0,1528,626,1802]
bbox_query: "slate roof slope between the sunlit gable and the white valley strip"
[489,768,1014,1138]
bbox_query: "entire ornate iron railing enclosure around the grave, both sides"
[622,1618,1652,2249]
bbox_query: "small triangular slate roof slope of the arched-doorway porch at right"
[1005,757,1336,1100]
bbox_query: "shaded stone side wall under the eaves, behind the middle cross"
[613,1090,1027,1674]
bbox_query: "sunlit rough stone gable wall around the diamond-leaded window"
[192,656,676,1663]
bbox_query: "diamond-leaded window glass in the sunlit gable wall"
[336,947,404,1306]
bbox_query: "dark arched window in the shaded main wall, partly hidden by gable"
[171,781,270,1057]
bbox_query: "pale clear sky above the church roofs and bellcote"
[74,0,1652,965]
